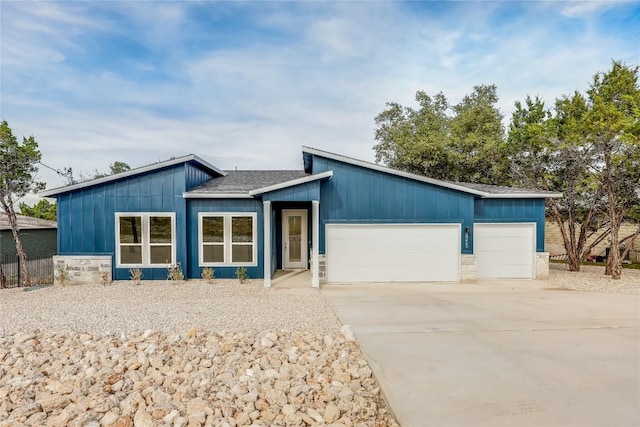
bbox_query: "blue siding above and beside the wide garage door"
[312,155,474,254]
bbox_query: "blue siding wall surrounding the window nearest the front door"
[185,199,264,279]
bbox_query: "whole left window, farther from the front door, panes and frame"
[116,213,176,267]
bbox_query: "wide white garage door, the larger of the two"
[326,224,460,283]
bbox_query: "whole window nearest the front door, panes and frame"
[199,213,257,266]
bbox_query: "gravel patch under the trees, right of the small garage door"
[548,263,640,295]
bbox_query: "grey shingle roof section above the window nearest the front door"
[189,170,310,194]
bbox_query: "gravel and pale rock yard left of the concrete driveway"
[0,281,397,427]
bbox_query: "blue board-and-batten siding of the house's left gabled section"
[57,163,212,280]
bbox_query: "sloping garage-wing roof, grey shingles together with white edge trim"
[302,147,562,199]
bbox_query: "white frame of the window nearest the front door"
[198,212,258,267]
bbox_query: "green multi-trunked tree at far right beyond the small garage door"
[505,62,640,279]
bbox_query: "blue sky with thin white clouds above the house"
[0,0,640,196]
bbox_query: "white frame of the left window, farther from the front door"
[115,212,176,268]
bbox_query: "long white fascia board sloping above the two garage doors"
[302,146,563,199]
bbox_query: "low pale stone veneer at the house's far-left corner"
[53,255,112,285]
